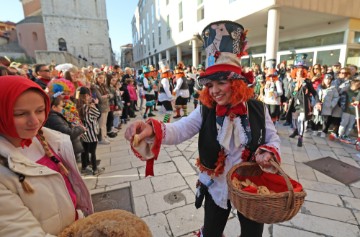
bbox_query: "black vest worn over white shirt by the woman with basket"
[198,99,266,170]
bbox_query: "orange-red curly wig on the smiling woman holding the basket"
[199,80,254,108]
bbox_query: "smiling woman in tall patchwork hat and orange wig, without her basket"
[125,21,280,237]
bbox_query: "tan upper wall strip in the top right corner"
[275,0,360,18]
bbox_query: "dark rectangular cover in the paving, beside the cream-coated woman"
[91,187,134,213]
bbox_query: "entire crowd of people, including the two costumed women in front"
[0,18,360,236]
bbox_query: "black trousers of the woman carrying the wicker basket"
[202,191,264,237]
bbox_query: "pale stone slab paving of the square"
[84,105,360,237]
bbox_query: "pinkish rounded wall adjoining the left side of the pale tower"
[16,23,47,58]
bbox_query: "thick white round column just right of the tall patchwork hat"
[266,8,280,67]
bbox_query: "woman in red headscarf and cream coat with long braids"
[0,76,93,236]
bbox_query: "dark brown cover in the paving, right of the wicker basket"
[304,157,360,185]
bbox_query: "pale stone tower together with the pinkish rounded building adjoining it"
[17,0,112,66]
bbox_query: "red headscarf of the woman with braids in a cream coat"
[0,76,50,147]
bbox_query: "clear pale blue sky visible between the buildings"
[0,0,138,52]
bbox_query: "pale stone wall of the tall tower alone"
[41,0,112,65]
